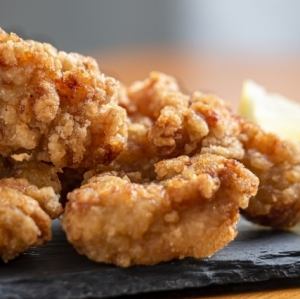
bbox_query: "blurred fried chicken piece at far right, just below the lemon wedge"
[241,120,300,228]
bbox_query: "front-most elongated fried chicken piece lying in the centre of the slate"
[62,154,258,267]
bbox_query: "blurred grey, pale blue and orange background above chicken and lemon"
[0,0,300,103]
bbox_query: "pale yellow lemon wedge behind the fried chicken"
[239,80,300,143]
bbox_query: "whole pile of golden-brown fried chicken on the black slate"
[0,30,300,267]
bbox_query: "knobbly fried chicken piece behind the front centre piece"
[120,72,244,159]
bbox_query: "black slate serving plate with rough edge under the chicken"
[0,221,300,299]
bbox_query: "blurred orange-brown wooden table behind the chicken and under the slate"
[92,48,300,299]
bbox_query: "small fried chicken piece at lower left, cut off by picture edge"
[0,178,62,262]
